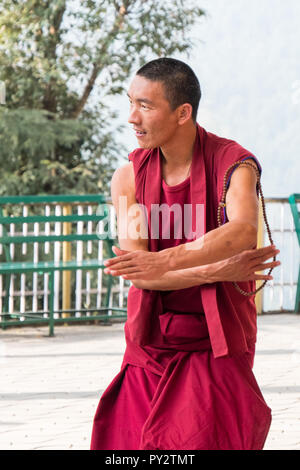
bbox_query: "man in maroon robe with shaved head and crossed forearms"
[91,58,280,450]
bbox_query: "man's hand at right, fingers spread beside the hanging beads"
[208,245,281,282]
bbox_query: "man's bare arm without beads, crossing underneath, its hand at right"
[105,163,279,290]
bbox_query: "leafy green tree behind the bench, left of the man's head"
[0,0,204,194]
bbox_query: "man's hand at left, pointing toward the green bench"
[104,246,168,280]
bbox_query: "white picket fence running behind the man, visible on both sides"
[0,198,299,316]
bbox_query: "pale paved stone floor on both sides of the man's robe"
[0,314,300,450]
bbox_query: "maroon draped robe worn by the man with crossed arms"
[91,125,271,450]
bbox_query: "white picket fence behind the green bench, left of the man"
[0,200,130,320]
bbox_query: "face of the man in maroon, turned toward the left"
[128,75,178,148]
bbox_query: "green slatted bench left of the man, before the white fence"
[0,195,126,336]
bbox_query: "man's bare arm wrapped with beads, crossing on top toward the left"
[106,163,270,280]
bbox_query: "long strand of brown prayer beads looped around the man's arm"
[217,161,276,296]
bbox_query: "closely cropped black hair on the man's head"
[136,57,201,122]
